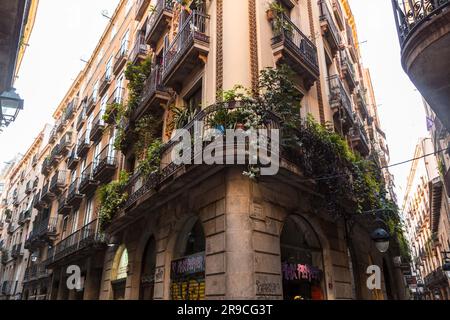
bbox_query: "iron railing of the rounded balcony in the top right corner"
[392,0,450,46]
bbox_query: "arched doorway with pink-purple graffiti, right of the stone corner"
[280,216,326,300]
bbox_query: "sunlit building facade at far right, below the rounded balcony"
[403,138,449,300]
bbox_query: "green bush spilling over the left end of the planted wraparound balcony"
[97,171,129,230]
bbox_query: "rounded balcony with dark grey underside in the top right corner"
[392,0,450,129]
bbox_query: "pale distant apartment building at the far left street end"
[0,126,49,299]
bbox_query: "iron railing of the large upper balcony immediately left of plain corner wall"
[163,10,209,77]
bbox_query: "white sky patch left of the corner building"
[0,0,119,167]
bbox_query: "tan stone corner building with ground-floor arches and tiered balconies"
[0,0,405,300]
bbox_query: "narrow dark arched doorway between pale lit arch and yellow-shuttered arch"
[139,237,156,300]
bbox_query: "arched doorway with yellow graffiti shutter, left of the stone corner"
[170,219,206,300]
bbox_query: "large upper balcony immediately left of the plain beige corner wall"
[162,11,209,91]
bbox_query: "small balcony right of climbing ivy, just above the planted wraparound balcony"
[132,66,170,121]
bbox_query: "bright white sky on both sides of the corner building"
[0,0,427,204]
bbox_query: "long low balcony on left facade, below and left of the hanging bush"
[46,220,106,267]
